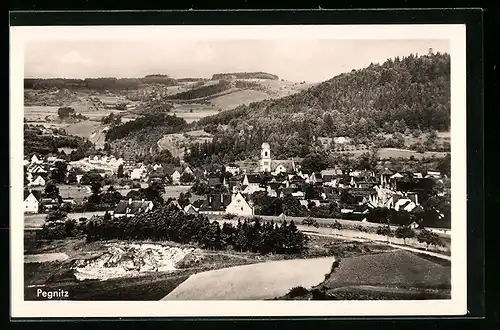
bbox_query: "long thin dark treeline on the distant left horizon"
[24,75,177,91]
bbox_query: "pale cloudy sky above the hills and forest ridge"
[24,39,450,82]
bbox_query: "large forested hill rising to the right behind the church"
[199,53,450,136]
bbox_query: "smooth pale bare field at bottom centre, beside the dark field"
[162,257,335,300]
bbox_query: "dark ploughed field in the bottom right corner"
[279,250,451,300]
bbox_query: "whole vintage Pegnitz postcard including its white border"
[10,25,467,317]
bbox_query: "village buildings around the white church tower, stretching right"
[178,143,441,220]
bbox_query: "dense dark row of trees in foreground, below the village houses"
[86,206,307,254]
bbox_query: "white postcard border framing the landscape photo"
[10,25,467,318]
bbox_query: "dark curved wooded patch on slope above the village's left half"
[106,113,187,141]
